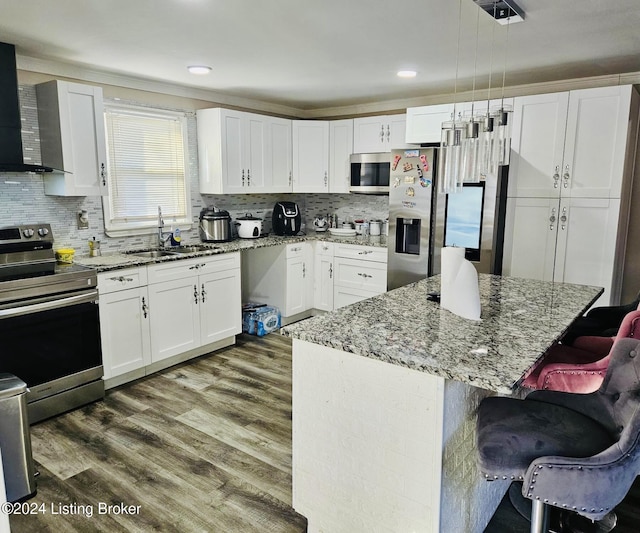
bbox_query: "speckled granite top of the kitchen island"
[282,274,602,394]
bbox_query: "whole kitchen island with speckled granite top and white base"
[283,274,602,533]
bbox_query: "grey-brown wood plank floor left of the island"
[10,334,306,533]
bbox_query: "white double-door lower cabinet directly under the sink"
[148,252,242,363]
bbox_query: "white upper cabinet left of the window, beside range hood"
[36,80,108,196]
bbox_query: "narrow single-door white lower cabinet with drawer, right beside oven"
[98,267,151,379]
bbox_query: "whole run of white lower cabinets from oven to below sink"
[98,252,242,388]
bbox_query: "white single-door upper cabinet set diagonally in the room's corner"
[292,120,329,192]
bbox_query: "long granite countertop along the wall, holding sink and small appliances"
[74,232,387,272]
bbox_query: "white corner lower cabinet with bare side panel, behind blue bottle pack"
[242,242,313,323]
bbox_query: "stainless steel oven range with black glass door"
[0,224,104,423]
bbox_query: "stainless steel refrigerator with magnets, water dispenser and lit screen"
[387,148,508,290]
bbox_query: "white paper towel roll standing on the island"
[440,246,480,320]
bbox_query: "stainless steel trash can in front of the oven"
[0,373,36,502]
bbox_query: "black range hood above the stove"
[0,43,54,173]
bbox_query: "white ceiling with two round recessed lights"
[0,0,640,116]
